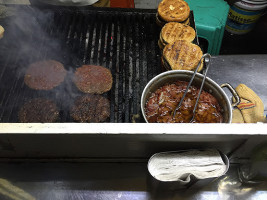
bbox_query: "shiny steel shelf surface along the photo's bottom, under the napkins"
[0,162,267,200]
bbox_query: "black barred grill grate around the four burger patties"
[0,6,161,123]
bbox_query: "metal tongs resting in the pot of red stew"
[172,53,211,123]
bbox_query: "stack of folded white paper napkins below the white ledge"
[148,149,228,183]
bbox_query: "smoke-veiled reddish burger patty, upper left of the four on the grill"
[24,60,67,90]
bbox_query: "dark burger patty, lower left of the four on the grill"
[18,98,59,123]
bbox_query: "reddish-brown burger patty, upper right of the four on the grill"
[73,65,113,94]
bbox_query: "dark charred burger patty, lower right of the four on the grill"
[70,94,110,122]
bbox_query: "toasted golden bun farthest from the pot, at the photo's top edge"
[158,0,190,22]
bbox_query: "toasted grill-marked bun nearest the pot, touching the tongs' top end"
[163,40,203,71]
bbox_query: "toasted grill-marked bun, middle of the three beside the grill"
[160,22,196,44]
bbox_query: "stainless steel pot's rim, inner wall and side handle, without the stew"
[141,70,240,123]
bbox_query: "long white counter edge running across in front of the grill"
[0,123,267,135]
